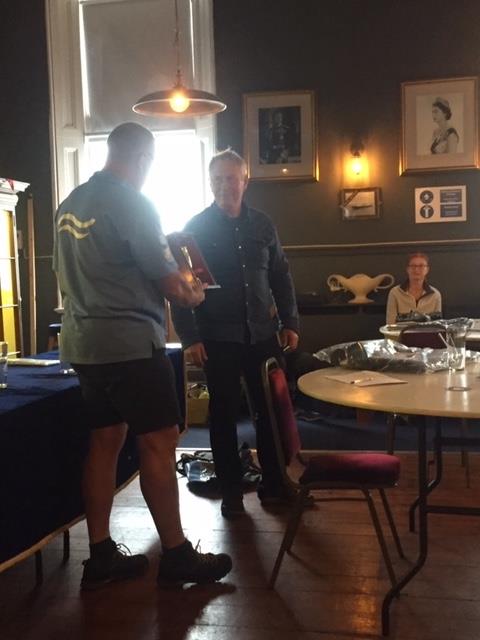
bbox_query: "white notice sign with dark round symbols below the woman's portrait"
[415,185,467,224]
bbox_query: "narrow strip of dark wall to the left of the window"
[0,0,58,352]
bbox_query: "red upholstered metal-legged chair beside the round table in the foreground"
[262,358,404,587]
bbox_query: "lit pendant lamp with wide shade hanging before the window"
[132,0,227,118]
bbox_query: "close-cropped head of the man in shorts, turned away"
[105,122,155,189]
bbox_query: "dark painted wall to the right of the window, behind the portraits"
[215,0,480,349]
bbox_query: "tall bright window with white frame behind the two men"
[46,0,215,212]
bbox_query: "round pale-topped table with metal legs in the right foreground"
[298,363,480,635]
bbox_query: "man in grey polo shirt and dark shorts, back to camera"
[53,123,232,589]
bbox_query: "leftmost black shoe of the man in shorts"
[80,543,148,591]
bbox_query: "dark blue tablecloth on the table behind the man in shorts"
[0,349,184,565]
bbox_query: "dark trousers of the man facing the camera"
[204,336,283,493]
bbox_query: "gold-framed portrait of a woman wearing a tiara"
[400,78,478,174]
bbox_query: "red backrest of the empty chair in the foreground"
[262,358,301,470]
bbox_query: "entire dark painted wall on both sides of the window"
[0,0,480,349]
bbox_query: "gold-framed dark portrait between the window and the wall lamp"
[243,91,318,180]
